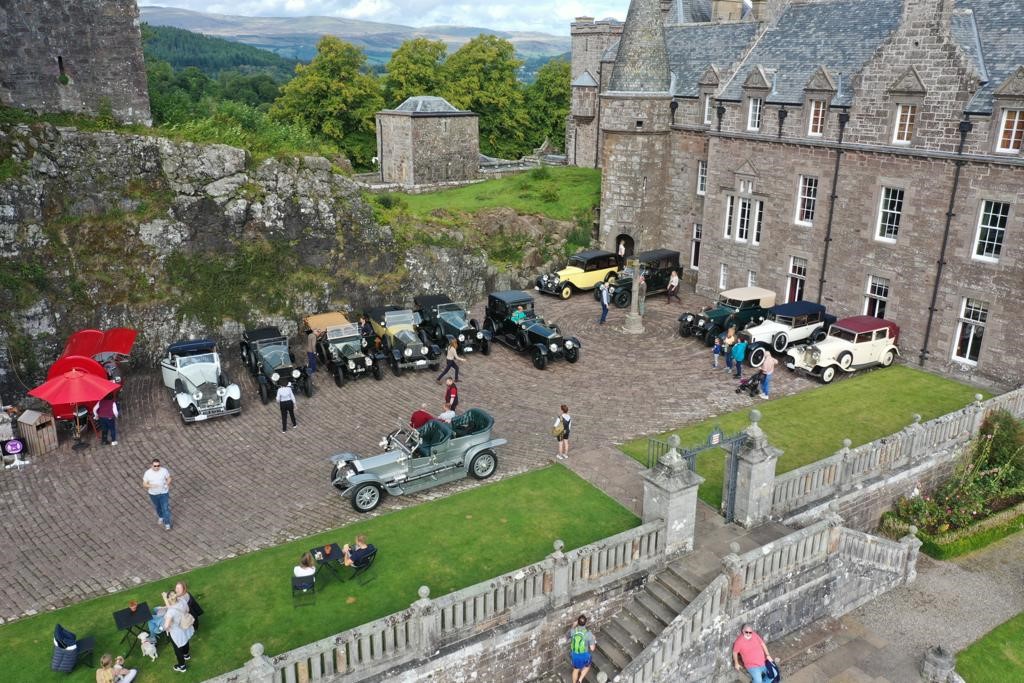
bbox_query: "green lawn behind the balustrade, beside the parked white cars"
[621,366,989,509]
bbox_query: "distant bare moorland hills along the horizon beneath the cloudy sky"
[139,6,569,65]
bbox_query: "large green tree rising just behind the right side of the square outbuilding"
[441,35,529,159]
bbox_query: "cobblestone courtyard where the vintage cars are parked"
[0,293,812,620]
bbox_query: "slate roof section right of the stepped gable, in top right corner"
[953,0,1024,114]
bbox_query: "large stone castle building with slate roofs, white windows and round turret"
[566,0,1024,385]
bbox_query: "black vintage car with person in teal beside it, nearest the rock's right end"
[483,290,580,370]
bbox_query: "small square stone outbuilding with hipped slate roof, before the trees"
[377,95,480,186]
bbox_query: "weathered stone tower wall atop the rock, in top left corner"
[0,0,151,125]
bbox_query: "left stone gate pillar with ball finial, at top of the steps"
[634,438,703,555]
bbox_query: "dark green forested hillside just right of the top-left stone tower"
[142,24,298,82]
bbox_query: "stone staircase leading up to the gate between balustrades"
[587,558,707,681]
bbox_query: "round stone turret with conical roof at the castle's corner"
[601,0,672,251]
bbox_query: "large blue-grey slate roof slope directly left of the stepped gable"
[719,0,903,106]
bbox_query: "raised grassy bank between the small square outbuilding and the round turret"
[396,166,601,220]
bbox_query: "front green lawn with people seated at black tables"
[0,465,640,682]
